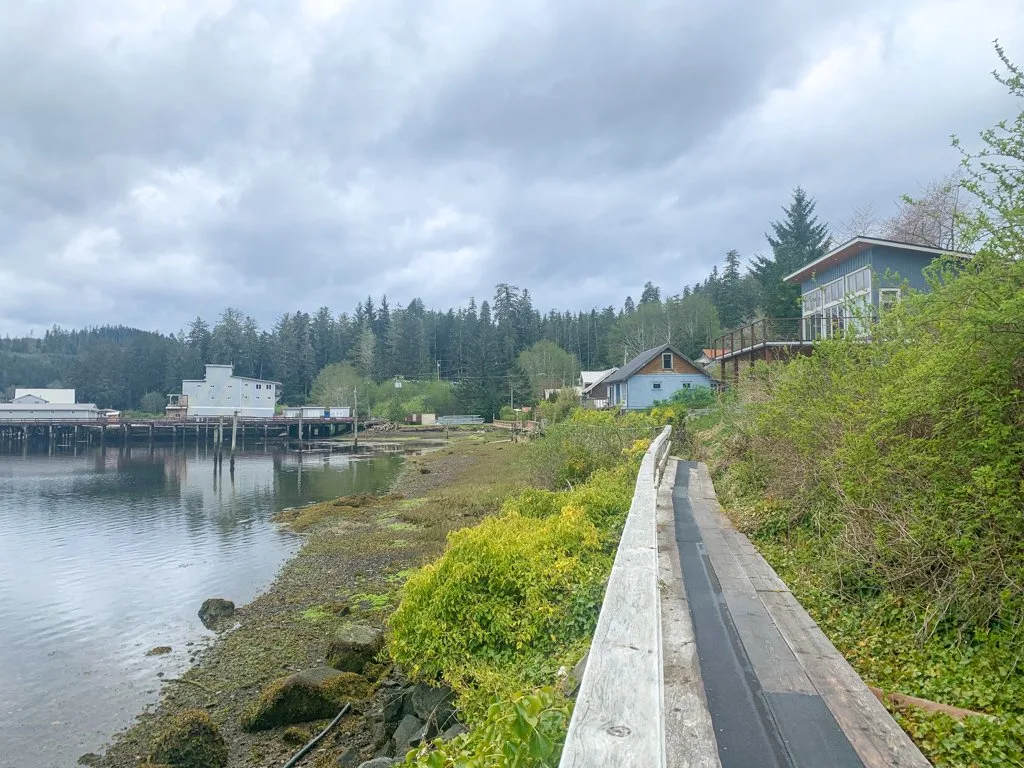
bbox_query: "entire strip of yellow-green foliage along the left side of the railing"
[389,411,654,766]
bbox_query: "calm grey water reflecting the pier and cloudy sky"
[0,446,401,768]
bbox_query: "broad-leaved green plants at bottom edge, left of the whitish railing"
[404,687,571,768]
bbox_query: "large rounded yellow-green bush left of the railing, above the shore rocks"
[390,505,611,693]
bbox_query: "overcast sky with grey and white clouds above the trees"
[0,0,1024,335]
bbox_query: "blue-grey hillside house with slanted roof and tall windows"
[784,238,973,340]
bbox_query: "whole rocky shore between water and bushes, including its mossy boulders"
[99,431,518,768]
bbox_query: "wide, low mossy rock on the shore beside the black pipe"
[242,667,372,731]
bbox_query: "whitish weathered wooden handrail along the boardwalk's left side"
[559,427,672,768]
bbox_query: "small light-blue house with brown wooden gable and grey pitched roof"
[598,344,714,411]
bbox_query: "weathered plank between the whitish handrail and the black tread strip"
[657,460,721,768]
